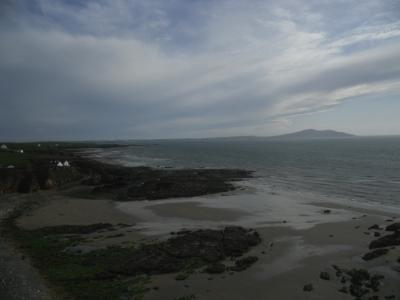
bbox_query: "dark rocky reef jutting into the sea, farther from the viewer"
[77,160,251,201]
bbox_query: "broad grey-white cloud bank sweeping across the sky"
[0,1,400,139]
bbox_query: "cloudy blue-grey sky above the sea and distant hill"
[0,0,400,141]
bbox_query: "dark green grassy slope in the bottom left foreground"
[3,219,150,300]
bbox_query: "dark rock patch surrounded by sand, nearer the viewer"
[111,227,261,275]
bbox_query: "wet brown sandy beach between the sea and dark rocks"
[10,179,400,300]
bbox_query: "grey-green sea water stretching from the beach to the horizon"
[93,137,400,206]
